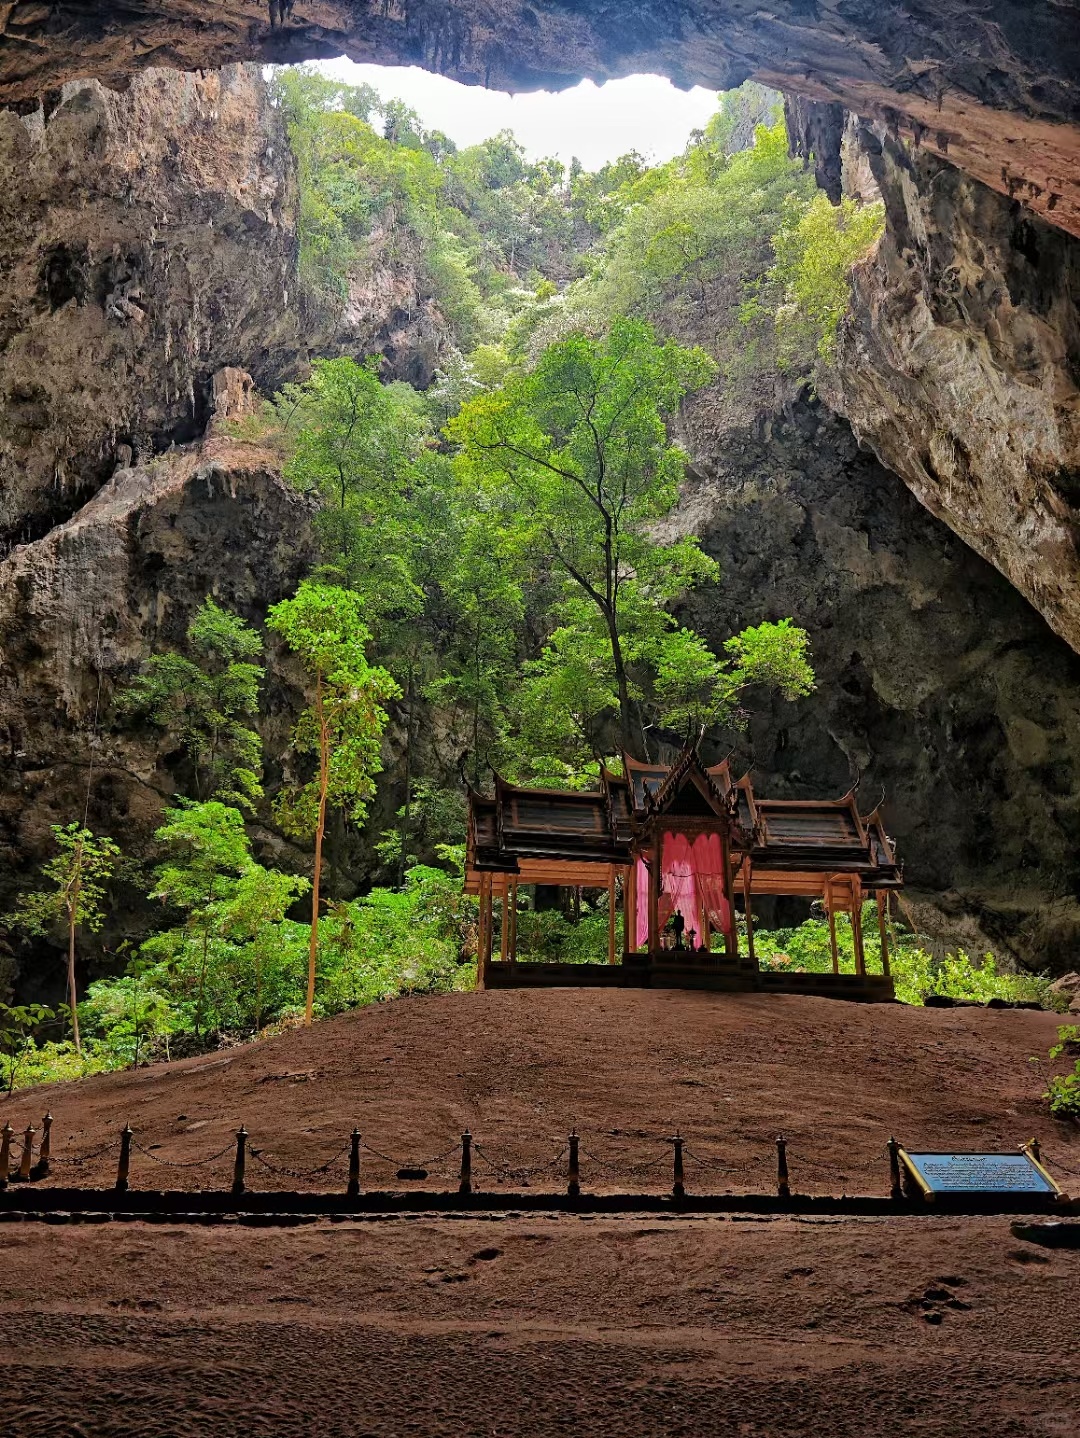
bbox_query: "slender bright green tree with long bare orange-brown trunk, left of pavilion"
[269,581,401,1024]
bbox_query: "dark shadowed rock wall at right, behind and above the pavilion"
[679,401,1080,969]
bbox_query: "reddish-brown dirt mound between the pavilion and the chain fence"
[0,989,1080,1192]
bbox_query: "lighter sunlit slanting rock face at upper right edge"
[830,125,1080,650]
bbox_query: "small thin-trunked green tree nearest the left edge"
[7,824,119,1053]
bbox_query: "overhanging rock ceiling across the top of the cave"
[0,0,1080,234]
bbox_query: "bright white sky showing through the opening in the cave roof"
[307,59,718,170]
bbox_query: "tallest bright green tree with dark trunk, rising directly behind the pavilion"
[447,319,811,755]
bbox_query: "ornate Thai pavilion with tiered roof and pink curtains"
[466,745,902,1001]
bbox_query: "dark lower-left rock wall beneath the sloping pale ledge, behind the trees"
[0,436,314,977]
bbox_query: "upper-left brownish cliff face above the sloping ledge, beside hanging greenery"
[0,66,444,552]
